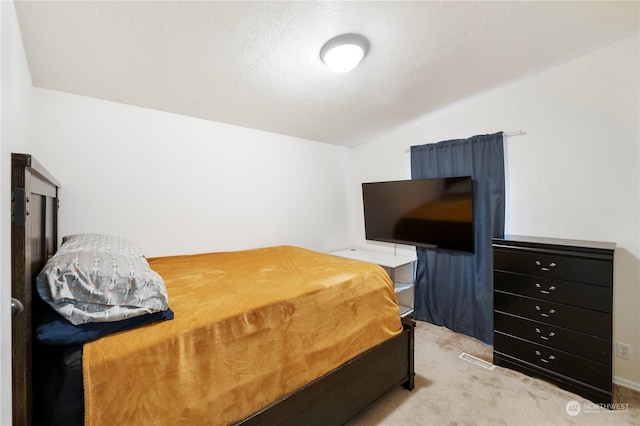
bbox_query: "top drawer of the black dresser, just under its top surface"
[493,248,613,287]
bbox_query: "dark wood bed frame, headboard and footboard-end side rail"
[11,154,415,426]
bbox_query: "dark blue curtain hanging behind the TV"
[411,133,505,344]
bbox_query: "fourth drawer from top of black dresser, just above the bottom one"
[493,312,611,364]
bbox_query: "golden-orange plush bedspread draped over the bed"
[83,246,402,425]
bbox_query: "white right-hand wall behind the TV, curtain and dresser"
[349,36,640,389]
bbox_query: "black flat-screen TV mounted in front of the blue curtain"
[362,176,474,252]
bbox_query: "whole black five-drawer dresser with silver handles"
[493,235,615,403]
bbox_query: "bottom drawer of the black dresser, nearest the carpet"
[493,332,613,391]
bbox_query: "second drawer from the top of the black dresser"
[493,271,612,313]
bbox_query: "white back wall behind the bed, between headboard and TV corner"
[28,89,351,256]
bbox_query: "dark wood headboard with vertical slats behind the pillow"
[11,154,60,426]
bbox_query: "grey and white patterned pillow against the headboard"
[36,245,168,325]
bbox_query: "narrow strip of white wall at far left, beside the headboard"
[0,1,33,425]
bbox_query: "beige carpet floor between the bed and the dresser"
[349,321,640,426]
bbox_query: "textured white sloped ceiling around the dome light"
[15,1,640,146]
